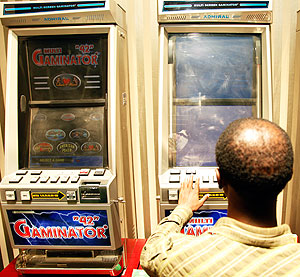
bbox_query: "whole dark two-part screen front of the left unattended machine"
[18,33,108,168]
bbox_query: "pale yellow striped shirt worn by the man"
[140,205,300,277]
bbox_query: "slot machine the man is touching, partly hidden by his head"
[158,0,272,236]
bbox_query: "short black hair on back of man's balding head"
[216,118,294,199]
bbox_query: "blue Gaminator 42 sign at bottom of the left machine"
[7,210,111,247]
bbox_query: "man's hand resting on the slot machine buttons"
[178,176,209,211]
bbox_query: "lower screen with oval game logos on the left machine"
[29,107,107,168]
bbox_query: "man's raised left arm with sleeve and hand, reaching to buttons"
[140,177,209,275]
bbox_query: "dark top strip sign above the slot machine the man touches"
[163,1,269,12]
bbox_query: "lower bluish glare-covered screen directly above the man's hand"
[175,106,252,167]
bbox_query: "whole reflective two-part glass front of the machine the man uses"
[169,33,261,167]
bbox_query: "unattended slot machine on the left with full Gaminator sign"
[0,0,126,276]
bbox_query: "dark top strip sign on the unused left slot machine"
[3,1,105,15]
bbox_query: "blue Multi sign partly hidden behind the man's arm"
[165,209,227,236]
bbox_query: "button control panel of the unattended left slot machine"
[1,168,117,204]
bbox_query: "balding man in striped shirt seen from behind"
[141,118,300,277]
